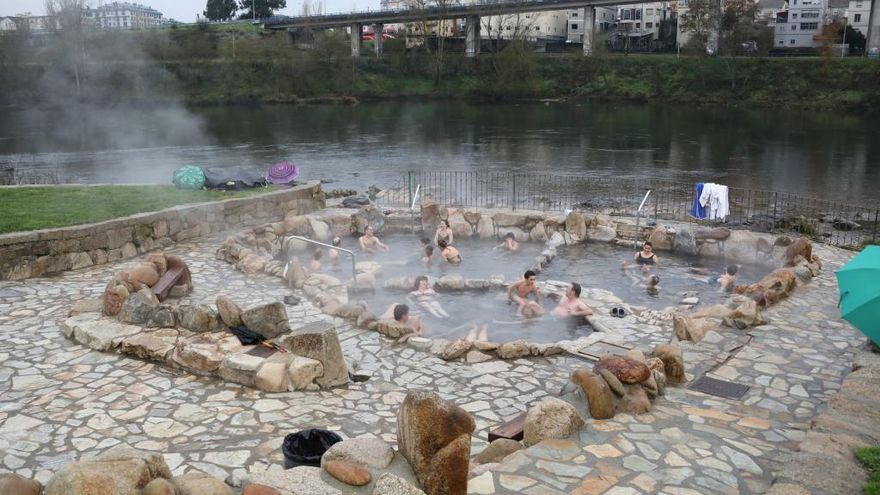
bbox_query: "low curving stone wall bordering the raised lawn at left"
[0,181,324,280]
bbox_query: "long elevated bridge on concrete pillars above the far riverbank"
[263,0,656,57]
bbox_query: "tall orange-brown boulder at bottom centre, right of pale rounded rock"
[397,391,476,495]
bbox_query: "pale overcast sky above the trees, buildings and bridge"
[0,0,379,22]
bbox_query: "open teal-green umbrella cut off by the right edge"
[837,246,880,345]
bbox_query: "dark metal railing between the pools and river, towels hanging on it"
[378,171,880,247]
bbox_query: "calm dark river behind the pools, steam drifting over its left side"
[0,102,880,202]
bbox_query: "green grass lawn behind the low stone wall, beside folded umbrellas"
[0,185,275,234]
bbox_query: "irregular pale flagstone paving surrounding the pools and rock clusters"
[0,239,864,495]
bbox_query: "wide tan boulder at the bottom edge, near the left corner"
[43,447,171,495]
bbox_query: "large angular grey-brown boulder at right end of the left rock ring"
[281,323,348,388]
